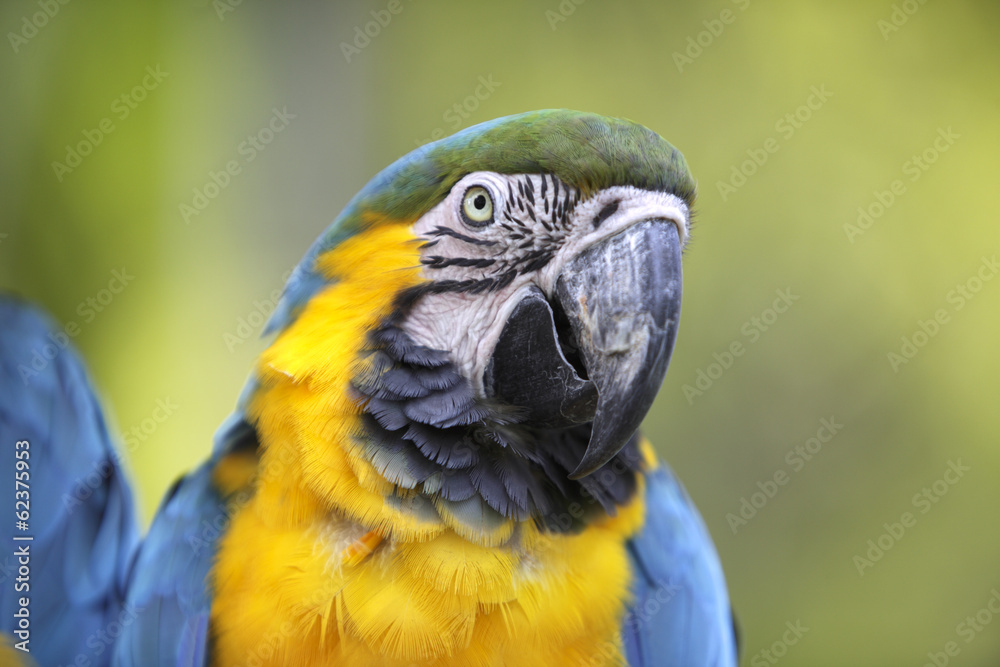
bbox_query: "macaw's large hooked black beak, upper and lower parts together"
[484,220,681,479]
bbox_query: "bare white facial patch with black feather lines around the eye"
[404,172,690,395]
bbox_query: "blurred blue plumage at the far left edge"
[0,295,138,665]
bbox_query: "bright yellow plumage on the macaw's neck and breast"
[212,223,648,666]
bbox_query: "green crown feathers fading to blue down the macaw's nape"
[265,109,695,340]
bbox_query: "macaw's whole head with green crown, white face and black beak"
[245,110,695,536]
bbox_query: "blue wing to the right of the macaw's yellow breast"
[622,465,736,667]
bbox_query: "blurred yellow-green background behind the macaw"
[0,0,1000,667]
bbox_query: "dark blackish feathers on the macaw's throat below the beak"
[352,294,640,532]
